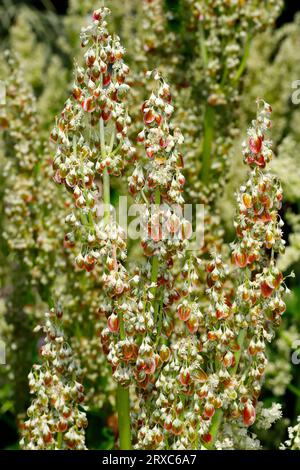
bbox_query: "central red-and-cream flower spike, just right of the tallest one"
[101,72,190,390]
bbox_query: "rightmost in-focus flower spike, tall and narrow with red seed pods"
[229,100,285,436]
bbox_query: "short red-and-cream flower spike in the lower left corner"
[20,307,87,450]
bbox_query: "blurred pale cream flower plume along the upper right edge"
[243,13,300,271]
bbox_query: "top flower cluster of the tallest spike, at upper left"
[52,8,134,184]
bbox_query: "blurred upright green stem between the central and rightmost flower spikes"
[200,104,215,184]
